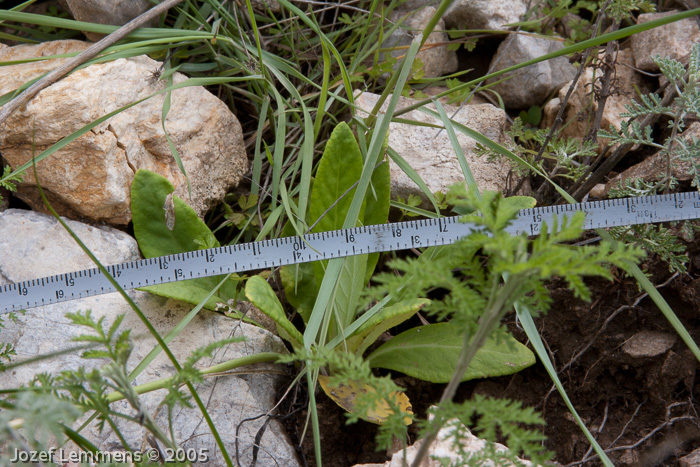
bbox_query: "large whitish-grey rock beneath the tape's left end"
[0,210,298,466]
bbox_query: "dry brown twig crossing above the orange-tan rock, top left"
[0,0,182,130]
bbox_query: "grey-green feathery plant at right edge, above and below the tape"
[598,44,700,272]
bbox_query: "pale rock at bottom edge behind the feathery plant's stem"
[354,419,532,467]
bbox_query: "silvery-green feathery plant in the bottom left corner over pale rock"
[0,310,179,465]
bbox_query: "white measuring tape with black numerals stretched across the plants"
[0,192,700,314]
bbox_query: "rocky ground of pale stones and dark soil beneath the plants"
[0,0,700,467]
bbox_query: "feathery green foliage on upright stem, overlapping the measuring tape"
[372,185,643,465]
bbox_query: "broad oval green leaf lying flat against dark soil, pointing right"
[367,323,535,383]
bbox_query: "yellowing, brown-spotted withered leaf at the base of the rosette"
[318,375,413,425]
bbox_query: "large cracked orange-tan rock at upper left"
[0,41,248,224]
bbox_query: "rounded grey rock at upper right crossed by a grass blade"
[487,34,576,109]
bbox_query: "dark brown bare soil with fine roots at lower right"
[278,234,700,467]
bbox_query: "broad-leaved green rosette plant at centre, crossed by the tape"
[245,123,534,421]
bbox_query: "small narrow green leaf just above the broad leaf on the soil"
[341,298,430,356]
